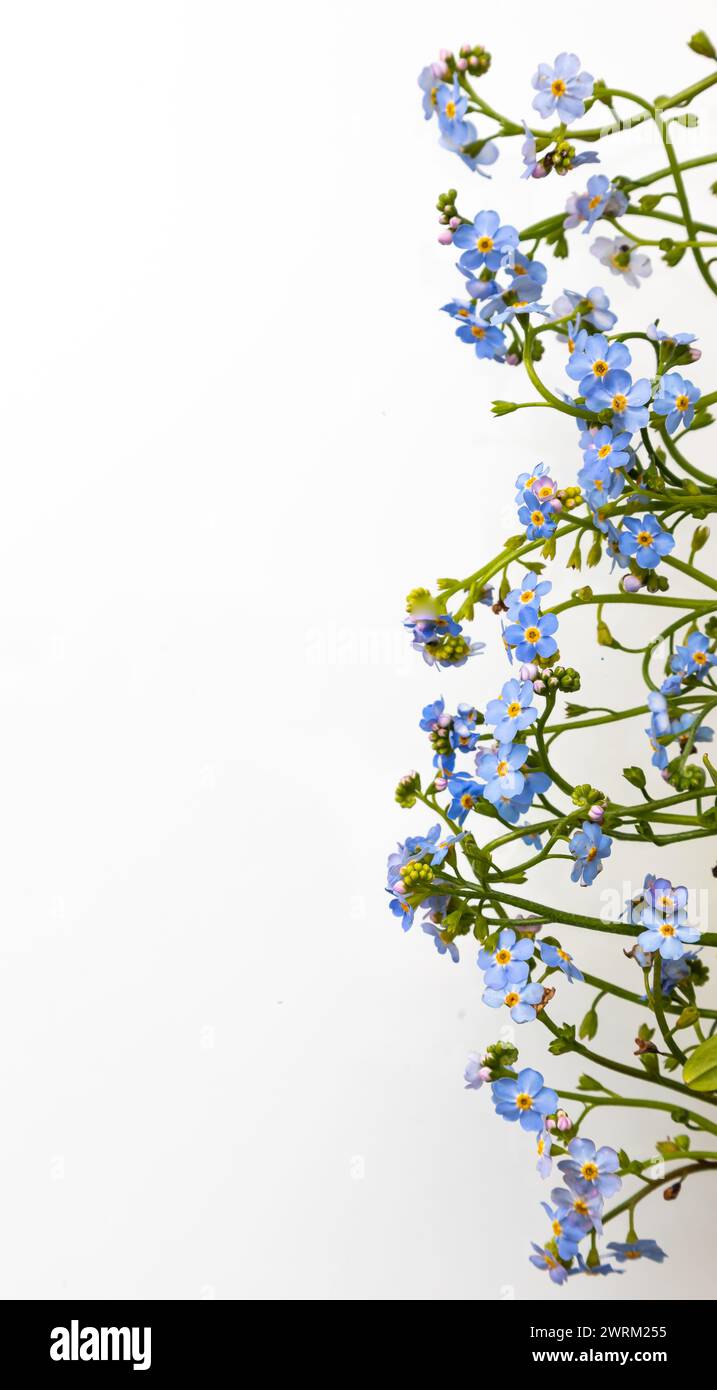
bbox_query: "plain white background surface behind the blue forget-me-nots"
[0,0,717,1300]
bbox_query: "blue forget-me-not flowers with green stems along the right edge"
[386,36,717,1286]
